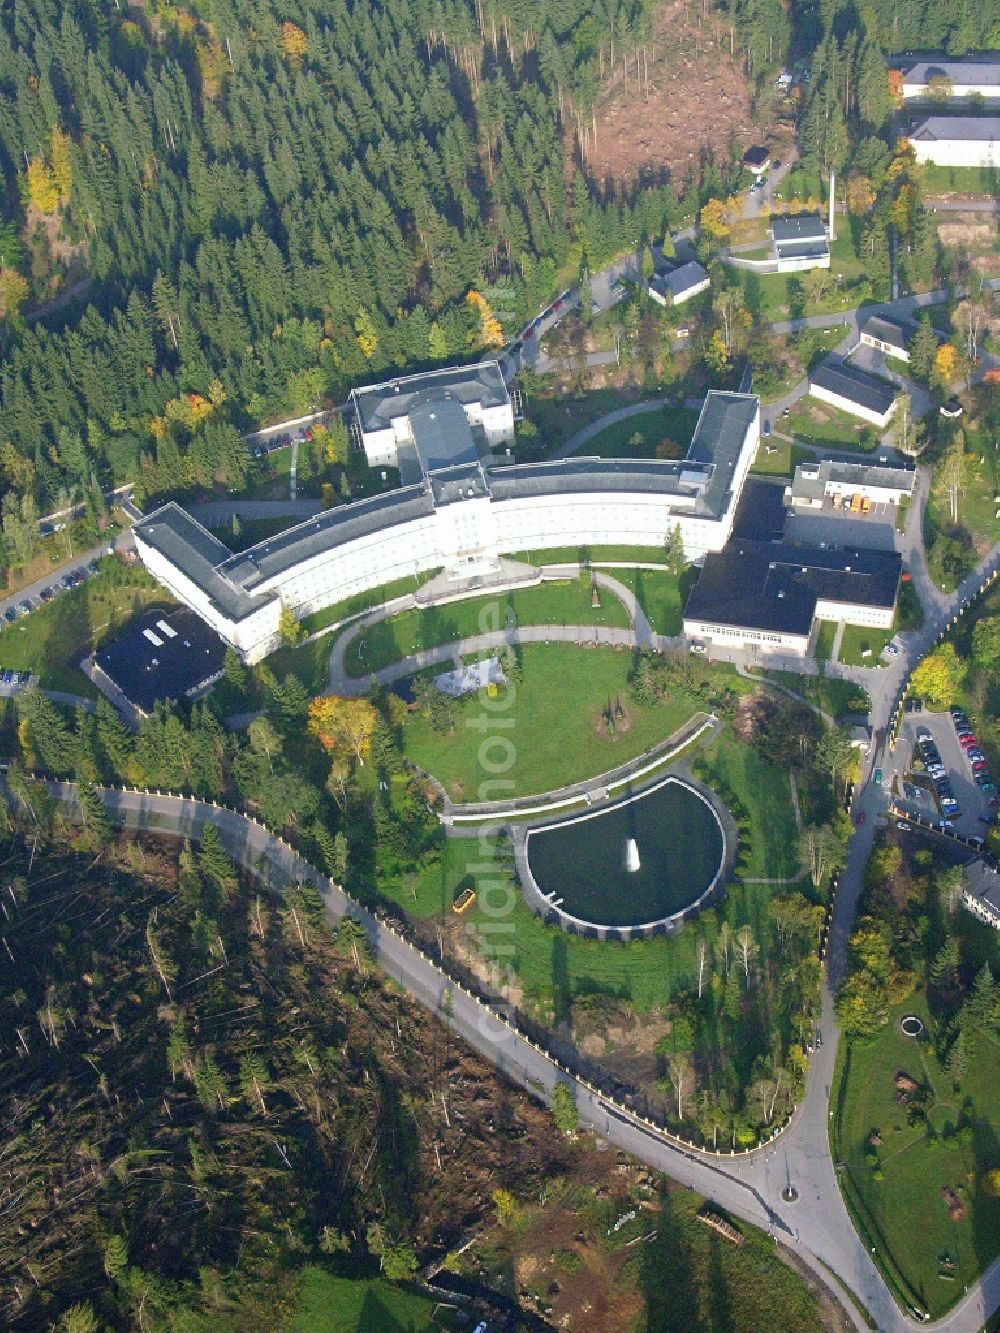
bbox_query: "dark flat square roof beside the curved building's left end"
[97,607,225,713]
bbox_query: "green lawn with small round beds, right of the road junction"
[839,997,1000,1318]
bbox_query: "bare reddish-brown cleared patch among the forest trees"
[585,0,759,183]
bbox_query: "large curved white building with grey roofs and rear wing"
[133,363,760,663]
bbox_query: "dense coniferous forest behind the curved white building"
[0,0,676,511]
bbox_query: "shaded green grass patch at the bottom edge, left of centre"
[289,1266,452,1333]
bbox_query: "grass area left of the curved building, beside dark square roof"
[0,556,176,698]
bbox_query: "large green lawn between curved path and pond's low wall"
[403,644,698,801]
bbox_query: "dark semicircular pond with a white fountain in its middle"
[525,777,725,926]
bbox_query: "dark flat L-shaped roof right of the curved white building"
[684,539,903,635]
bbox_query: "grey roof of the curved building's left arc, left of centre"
[221,485,433,591]
